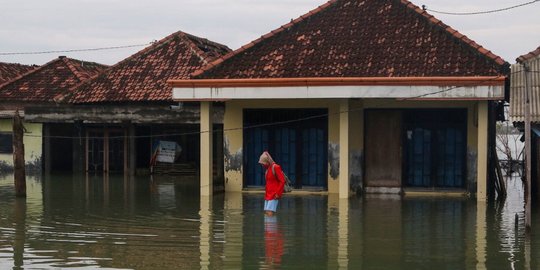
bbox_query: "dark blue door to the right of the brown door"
[404,110,467,188]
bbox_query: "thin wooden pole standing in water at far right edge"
[521,63,532,233]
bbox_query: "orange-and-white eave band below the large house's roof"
[168,76,505,101]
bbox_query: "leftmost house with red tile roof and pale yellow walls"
[0,57,105,172]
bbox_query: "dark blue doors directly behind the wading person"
[243,109,328,188]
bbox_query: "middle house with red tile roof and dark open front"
[27,32,229,177]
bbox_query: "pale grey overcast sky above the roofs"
[0,0,540,65]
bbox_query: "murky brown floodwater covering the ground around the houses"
[0,175,540,269]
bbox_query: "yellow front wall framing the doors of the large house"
[218,99,488,196]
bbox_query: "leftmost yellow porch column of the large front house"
[200,101,213,196]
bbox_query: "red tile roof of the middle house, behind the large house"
[64,31,230,103]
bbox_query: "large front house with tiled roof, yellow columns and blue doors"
[171,0,508,200]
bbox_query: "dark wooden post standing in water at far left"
[13,110,26,197]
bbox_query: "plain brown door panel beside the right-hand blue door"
[365,110,402,187]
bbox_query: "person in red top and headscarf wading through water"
[259,151,285,216]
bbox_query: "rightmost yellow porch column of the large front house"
[476,101,488,201]
